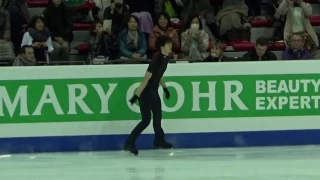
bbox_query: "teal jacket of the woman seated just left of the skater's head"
[118,29,148,58]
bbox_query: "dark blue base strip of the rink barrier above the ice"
[0,129,320,154]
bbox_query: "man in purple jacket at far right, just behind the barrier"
[282,33,313,60]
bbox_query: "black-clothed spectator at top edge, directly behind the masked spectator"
[178,0,220,39]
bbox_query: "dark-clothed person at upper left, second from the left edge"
[3,0,31,55]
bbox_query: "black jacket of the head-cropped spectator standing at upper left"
[43,1,73,42]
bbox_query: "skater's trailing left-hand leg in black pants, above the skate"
[126,99,151,144]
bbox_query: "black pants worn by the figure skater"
[126,89,164,144]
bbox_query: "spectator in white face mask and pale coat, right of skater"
[181,16,209,60]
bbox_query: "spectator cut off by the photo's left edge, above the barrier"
[0,0,15,62]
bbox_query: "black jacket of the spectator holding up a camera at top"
[103,4,129,35]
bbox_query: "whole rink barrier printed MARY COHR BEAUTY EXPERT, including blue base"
[0,61,320,152]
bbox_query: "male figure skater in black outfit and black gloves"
[124,35,172,155]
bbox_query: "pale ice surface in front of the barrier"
[0,146,320,180]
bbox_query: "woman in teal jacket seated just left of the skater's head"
[118,15,147,59]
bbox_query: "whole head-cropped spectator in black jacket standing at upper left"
[43,0,73,61]
